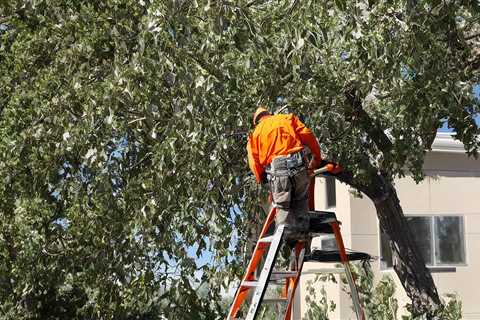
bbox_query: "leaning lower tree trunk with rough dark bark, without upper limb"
[337,171,441,319]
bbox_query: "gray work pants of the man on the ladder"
[268,166,310,237]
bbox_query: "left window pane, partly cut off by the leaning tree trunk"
[407,217,433,265]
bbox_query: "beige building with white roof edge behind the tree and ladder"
[295,133,480,320]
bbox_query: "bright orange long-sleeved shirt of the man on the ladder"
[247,114,321,182]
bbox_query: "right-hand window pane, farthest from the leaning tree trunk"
[435,216,465,264]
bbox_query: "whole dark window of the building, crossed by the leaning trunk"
[380,216,466,269]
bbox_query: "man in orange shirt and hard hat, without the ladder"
[247,107,322,238]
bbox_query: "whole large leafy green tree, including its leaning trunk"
[0,0,480,319]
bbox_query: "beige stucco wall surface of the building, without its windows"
[296,152,480,320]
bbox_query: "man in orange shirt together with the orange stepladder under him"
[231,108,365,320]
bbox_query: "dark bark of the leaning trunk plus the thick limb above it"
[337,84,441,319]
